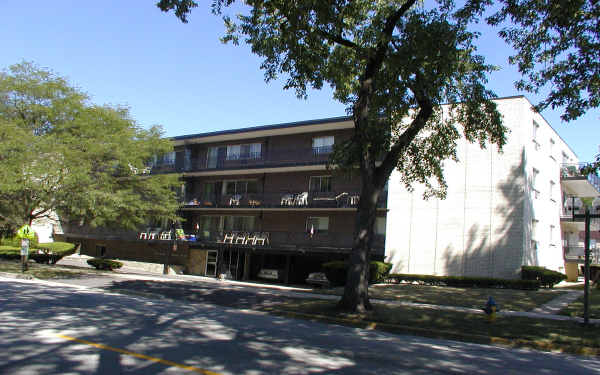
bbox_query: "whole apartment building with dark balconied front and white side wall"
[65,96,600,283]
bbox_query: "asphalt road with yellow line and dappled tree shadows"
[0,278,600,375]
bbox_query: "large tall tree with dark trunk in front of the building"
[158,0,506,311]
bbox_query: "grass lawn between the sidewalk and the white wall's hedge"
[314,284,565,311]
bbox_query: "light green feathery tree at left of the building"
[0,62,179,234]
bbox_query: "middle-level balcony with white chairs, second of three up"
[182,191,387,210]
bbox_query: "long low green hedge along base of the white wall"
[386,273,540,290]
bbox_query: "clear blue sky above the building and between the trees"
[0,0,600,161]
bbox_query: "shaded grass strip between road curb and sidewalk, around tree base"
[265,300,600,355]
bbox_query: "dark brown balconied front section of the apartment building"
[161,117,386,282]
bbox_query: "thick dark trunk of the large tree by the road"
[338,171,381,313]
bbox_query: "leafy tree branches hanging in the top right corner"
[465,0,600,121]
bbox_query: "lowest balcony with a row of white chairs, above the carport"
[186,230,385,254]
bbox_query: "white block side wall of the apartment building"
[386,97,574,278]
